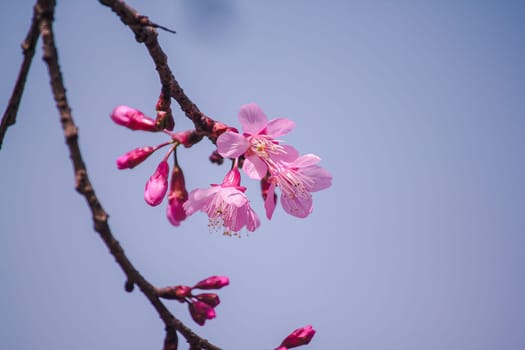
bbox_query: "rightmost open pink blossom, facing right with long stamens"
[264,146,332,219]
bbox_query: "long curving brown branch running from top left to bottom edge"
[37,0,220,350]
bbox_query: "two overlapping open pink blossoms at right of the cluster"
[217,103,332,219]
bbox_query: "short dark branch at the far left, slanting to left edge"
[0,3,44,149]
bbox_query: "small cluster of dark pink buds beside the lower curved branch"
[157,276,230,326]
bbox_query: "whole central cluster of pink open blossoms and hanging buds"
[111,103,332,235]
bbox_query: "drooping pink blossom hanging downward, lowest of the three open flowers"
[184,168,260,235]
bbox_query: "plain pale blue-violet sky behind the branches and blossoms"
[0,0,525,350]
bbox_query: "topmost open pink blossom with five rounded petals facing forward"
[217,103,295,180]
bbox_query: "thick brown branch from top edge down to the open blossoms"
[99,0,224,141]
